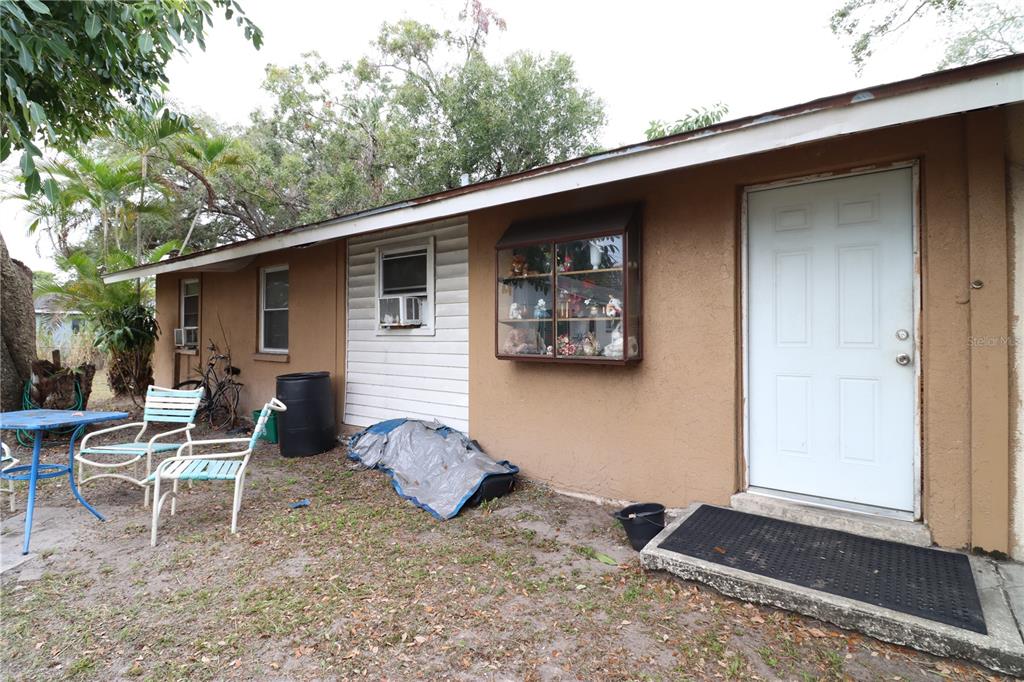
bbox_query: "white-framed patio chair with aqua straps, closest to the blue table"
[75,386,204,506]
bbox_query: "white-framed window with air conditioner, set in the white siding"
[377,240,434,332]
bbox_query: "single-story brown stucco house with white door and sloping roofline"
[105,55,1024,558]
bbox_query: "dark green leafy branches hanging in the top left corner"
[0,0,263,196]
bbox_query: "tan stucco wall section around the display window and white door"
[470,112,1009,550]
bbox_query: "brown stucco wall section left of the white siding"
[154,241,345,425]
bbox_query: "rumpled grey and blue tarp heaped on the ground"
[348,419,519,520]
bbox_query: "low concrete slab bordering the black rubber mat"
[641,505,1024,676]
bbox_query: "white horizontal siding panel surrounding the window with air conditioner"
[345,220,469,431]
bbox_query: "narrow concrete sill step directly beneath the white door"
[729,493,932,547]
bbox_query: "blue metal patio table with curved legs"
[0,410,128,554]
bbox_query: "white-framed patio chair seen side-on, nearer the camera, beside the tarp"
[148,397,288,547]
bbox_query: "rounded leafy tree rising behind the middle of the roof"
[352,5,605,197]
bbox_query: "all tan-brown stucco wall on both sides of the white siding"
[156,110,1019,551]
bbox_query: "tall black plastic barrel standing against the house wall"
[278,372,335,457]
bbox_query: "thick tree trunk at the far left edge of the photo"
[0,237,36,412]
